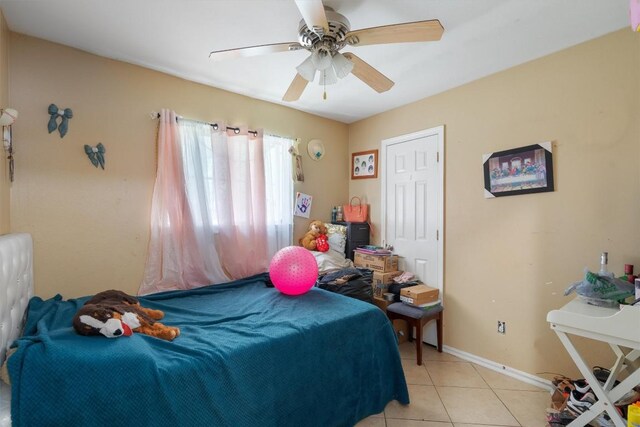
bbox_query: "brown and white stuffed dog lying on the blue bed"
[73,290,180,341]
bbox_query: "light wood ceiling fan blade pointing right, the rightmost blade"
[346,19,444,46]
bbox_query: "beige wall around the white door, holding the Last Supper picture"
[349,29,640,374]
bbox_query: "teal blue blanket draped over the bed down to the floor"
[8,275,409,427]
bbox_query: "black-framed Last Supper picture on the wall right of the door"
[482,142,553,199]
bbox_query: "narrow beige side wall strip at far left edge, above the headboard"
[0,10,11,234]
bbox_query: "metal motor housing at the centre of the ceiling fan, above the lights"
[298,6,351,53]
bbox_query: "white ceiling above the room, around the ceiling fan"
[0,0,629,123]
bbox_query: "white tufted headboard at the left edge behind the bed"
[0,233,33,364]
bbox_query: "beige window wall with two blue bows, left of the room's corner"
[9,33,348,297]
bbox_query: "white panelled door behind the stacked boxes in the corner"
[381,126,444,345]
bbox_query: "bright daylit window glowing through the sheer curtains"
[179,120,293,259]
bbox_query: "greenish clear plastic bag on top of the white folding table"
[564,269,635,306]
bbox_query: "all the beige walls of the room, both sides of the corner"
[6,26,640,380]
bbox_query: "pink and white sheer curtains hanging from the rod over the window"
[139,110,293,294]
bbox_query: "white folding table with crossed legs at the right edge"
[547,298,640,427]
